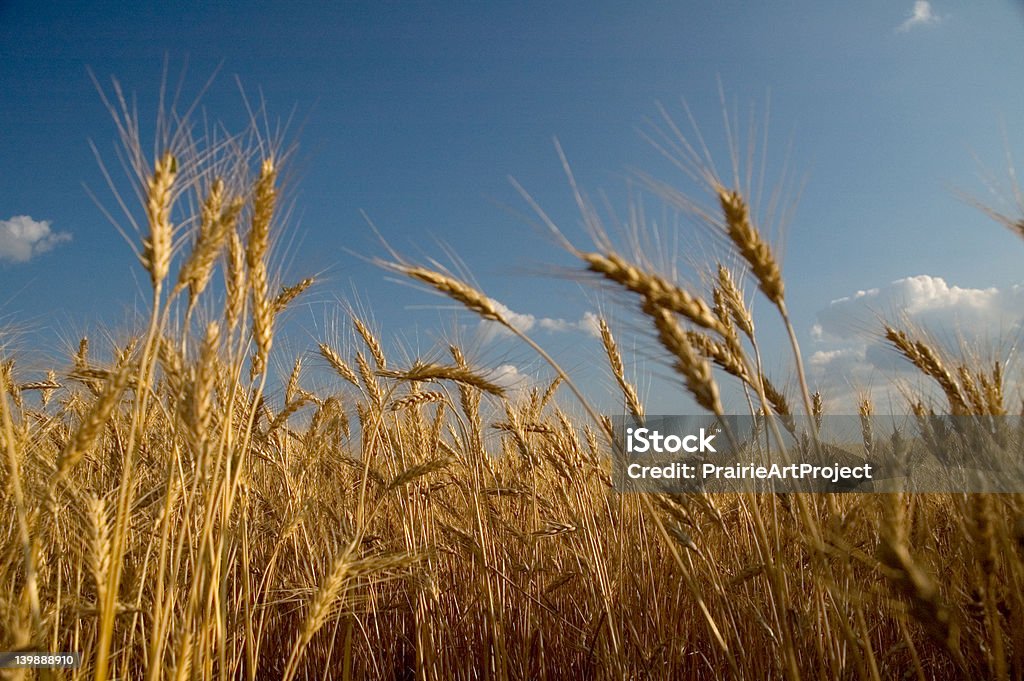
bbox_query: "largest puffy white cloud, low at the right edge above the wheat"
[808,274,1024,409]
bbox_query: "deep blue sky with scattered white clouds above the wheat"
[0,0,1024,405]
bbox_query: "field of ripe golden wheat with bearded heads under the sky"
[0,91,1024,681]
